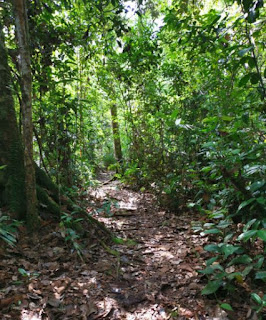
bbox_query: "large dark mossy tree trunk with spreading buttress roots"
[0,23,111,238]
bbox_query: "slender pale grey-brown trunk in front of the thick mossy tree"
[13,0,39,231]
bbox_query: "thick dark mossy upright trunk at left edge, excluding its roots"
[0,24,26,219]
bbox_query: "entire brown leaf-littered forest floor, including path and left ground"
[0,174,256,320]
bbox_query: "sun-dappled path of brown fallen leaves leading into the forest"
[82,174,228,320]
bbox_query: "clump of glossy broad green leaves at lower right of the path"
[193,214,266,314]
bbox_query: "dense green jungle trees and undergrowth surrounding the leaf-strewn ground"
[0,0,266,320]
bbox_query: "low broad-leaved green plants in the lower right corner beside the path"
[200,215,266,313]
